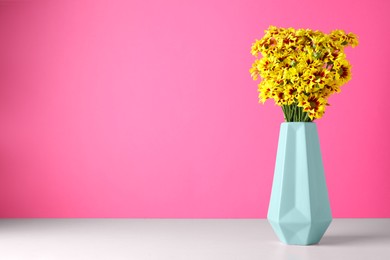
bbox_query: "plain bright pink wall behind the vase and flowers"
[0,0,390,218]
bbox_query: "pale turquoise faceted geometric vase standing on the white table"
[268,122,332,245]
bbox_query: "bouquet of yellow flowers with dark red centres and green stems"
[250,26,358,122]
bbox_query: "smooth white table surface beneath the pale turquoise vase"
[0,219,390,260]
